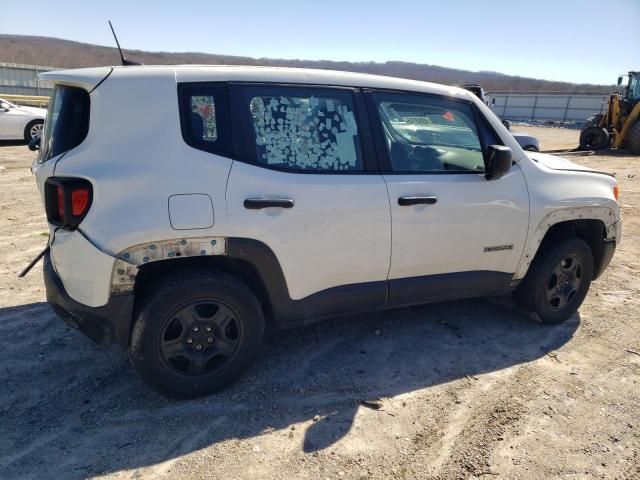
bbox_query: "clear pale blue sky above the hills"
[0,0,640,84]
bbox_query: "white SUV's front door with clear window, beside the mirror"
[367,91,529,305]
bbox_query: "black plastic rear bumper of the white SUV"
[43,254,134,346]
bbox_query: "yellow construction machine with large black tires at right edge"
[580,72,640,155]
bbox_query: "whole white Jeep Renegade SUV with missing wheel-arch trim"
[33,66,621,397]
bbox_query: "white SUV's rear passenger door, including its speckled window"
[226,84,391,317]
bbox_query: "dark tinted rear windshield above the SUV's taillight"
[40,86,90,162]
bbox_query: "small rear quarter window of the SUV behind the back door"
[178,83,231,156]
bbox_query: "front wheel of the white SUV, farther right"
[514,238,593,325]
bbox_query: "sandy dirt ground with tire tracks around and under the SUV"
[0,127,640,479]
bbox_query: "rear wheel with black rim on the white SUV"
[129,270,265,398]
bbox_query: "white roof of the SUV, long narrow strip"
[40,65,473,99]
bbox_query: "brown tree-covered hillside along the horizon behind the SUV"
[0,35,613,93]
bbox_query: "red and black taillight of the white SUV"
[44,177,93,230]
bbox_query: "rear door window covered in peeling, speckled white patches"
[243,87,363,173]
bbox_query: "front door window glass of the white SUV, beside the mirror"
[374,93,494,173]
